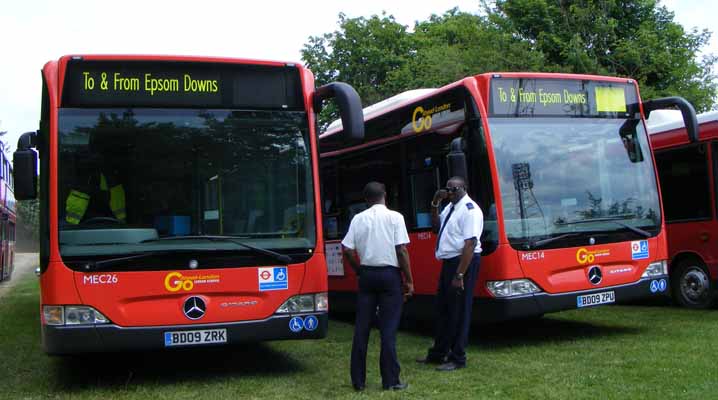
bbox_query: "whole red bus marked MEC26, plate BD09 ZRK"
[14,55,363,354]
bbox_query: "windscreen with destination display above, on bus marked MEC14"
[489,79,661,249]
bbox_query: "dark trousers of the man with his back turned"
[351,267,404,387]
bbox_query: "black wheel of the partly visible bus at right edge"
[671,260,714,309]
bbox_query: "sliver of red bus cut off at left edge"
[0,150,17,281]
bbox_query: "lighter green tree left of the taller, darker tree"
[302,9,543,124]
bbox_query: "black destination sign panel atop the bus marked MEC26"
[62,60,303,109]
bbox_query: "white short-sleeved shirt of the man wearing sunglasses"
[436,194,484,260]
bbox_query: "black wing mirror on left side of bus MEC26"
[12,132,37,200]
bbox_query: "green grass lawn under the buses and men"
[0,277,718,400]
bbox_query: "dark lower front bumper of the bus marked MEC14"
[474,275,670,322]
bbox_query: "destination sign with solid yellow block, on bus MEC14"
[490,78,638,118]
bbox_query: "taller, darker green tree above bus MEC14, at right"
[492,0,718,111]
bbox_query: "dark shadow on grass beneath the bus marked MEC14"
[332,313,643,349]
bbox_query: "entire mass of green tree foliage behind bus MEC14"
[302,0,718,126]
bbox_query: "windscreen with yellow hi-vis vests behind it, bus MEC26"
[58,108,315,257]
